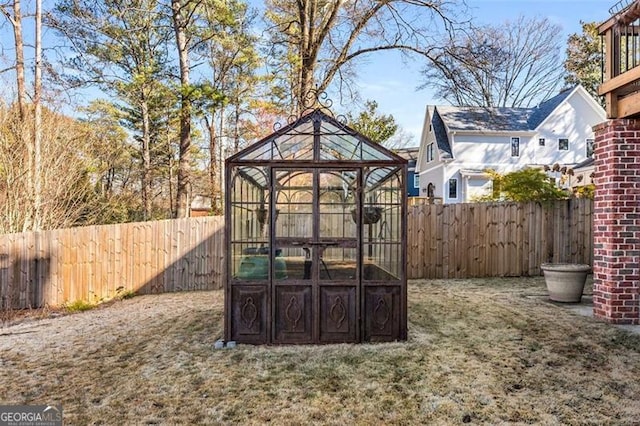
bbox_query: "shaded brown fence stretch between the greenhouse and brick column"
[407,199,593,279]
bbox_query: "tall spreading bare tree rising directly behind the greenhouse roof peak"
[266,0,464,110]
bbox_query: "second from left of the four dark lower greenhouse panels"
[274,285,313,343]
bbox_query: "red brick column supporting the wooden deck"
[593,120,640,324]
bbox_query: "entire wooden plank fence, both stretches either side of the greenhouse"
[0,199,593,309]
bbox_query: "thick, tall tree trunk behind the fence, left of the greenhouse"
[171,0,191,218]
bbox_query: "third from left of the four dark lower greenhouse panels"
[320,286,358,343]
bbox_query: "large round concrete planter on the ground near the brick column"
[540,263,591,303]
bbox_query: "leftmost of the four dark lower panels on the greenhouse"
[231,285,269,344]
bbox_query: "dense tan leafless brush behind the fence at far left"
[0,106,100,233]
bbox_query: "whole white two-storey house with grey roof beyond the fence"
[416,86,606,203]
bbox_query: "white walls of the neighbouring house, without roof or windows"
[419,87,605,203]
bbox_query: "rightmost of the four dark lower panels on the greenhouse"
[364,286,402,342]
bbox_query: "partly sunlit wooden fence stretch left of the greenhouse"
[0,217,225,309]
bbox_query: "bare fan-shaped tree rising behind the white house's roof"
[423,17,564,107]
